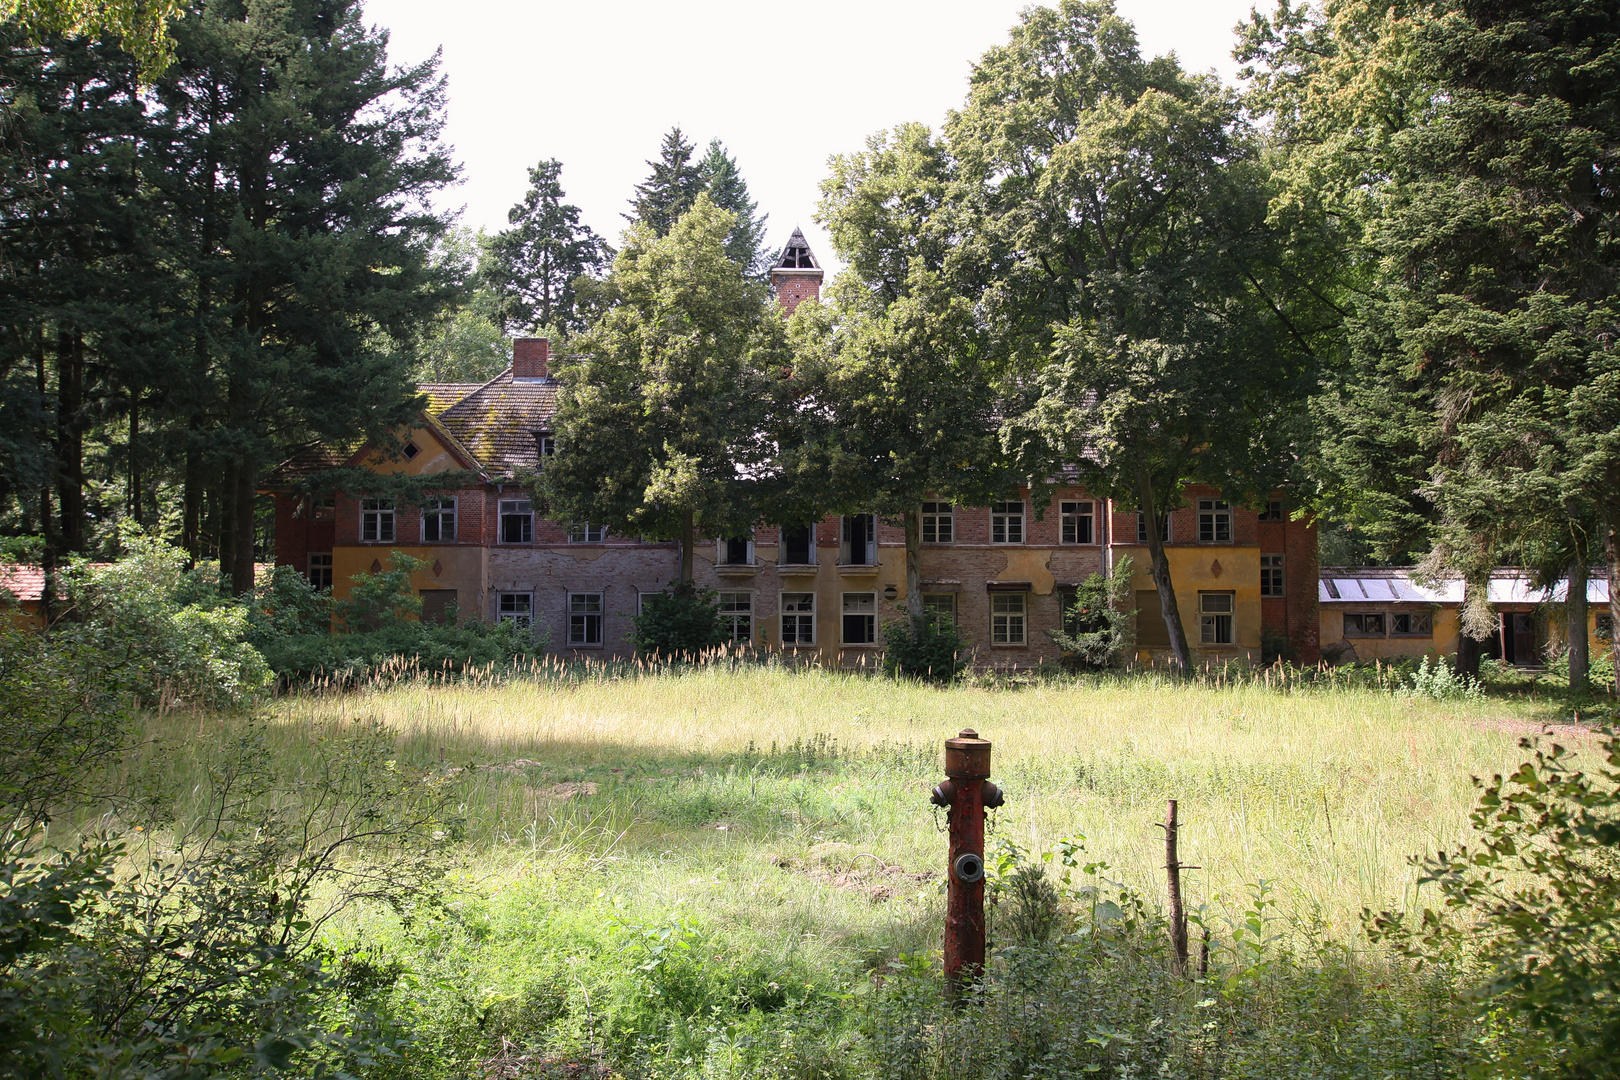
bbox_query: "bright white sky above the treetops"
[365,0,1272,270]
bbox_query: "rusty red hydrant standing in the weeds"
[928,727,1003,997]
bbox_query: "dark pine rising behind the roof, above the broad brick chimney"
[480,159,608,335]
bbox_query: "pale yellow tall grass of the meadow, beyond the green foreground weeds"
[132,665,1574,939]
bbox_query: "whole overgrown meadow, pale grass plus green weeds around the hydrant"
[130,665,1589,1077]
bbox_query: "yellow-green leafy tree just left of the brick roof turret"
[541,196,782,580]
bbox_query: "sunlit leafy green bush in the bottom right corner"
[1362,732,1620,1080]
